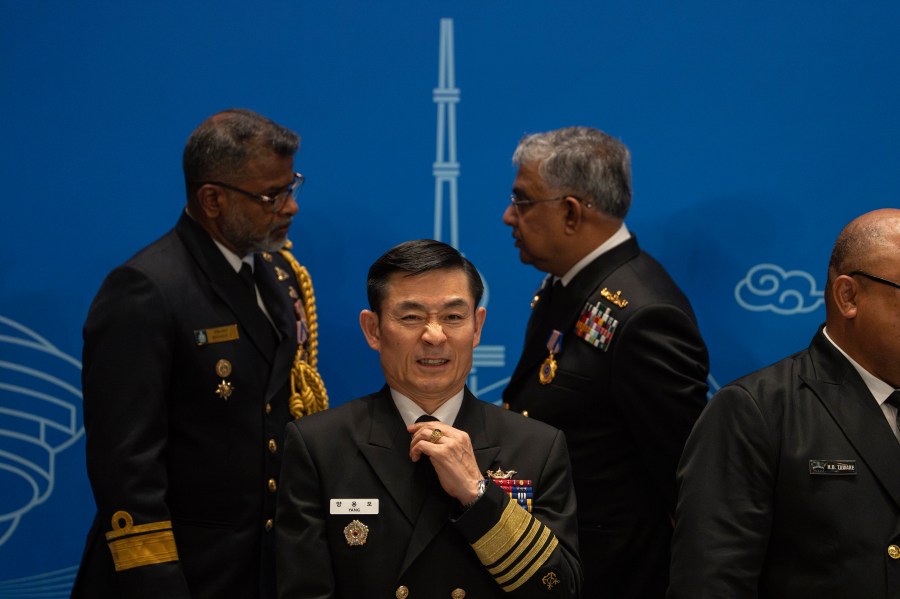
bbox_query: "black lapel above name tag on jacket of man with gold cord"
[175,214,275,362]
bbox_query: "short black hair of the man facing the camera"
[366,239,484,314]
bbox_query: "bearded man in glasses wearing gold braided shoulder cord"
[73,110,327,599]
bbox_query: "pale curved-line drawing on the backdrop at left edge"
[0,315,84,545]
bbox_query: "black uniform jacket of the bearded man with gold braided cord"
[73,214,310,599]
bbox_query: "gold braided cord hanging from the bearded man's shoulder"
[278,242,328,418]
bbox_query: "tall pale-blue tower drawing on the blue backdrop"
[432,19,509,402]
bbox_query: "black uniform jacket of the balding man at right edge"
[669,331,900,599]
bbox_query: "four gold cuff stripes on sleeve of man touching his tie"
[472,501,558,592]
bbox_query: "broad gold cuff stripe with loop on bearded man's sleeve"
[106,511,178,572]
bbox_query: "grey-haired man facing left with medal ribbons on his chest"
[503,127,709,599]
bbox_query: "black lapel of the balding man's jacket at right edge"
[800,331,900,506]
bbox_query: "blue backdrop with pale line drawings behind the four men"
[0,0,900,597]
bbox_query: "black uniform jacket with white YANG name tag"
[276,387,581,599]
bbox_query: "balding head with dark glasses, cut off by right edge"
[825,208,900,388]
